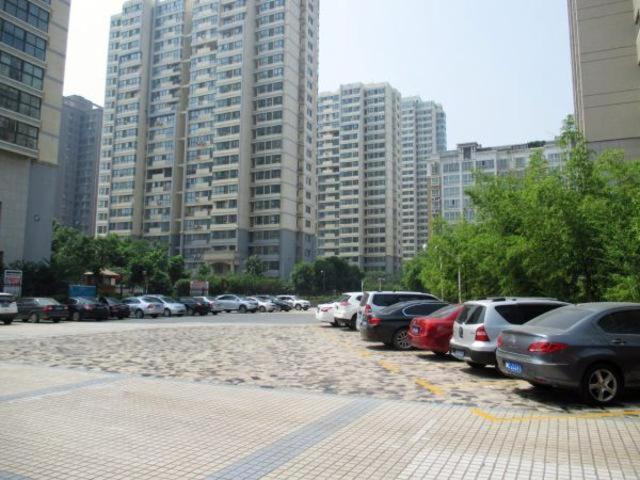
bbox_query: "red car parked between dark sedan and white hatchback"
[409,305,462,356]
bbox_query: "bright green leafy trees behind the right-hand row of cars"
[403,120,640,302]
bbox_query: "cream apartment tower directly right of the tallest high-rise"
[318,83,401,272]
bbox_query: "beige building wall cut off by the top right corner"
[568,0,640,159]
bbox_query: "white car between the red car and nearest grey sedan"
[449,298,567,368]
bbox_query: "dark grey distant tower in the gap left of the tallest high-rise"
[55,95,102,236]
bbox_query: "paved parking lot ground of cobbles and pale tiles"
[0,314,640,480]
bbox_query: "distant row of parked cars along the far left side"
[0,293,311,325]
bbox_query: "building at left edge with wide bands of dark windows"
[0,0,69,264]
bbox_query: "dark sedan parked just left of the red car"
[360,300,448,350]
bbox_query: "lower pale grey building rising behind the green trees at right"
[428,142,564,222]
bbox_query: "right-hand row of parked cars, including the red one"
[316,292,640,405]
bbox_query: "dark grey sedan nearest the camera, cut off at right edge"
[497,303,640,405]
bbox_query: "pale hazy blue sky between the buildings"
[65,0,573,148]
